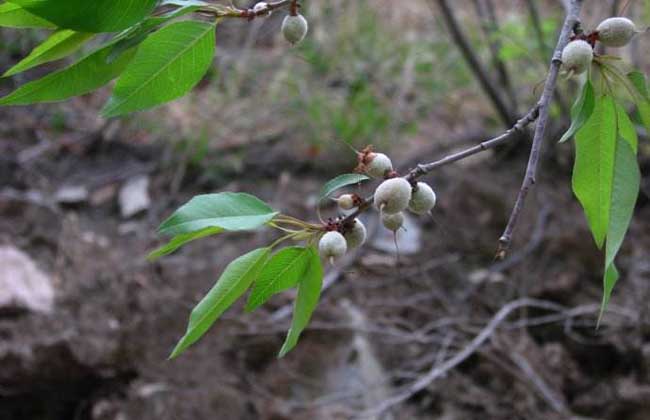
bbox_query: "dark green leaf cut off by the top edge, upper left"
[9,0,158,33]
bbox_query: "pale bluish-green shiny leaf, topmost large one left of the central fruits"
[158,192,278,235]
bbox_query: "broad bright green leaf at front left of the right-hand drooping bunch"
[572,95,617,248]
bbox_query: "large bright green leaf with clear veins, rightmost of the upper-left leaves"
[102,21,215,117]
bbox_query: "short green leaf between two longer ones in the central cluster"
[246,246,311,312]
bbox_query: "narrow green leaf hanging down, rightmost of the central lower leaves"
[278,247,323,357]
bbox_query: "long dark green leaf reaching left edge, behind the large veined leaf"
[0,44,135,105]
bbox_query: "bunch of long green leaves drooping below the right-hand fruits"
[563,64,647,319]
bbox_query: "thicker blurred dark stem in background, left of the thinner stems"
[435,0,516,126]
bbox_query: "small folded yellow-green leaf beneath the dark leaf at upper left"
[2,29,94,77]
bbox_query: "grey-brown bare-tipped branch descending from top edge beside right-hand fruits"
[496,0,582,259]
